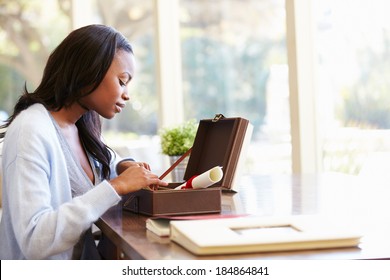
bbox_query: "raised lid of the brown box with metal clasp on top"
[184,114,253,191]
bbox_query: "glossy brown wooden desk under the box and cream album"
[97,174,390,260]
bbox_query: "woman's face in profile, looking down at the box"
[80,50,135,119]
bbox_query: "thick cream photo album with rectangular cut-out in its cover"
[169,216,361,255]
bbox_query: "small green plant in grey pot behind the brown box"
[159,119,198,182]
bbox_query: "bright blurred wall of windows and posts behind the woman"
[0,0,390,179]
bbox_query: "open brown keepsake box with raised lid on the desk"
[123,115,252,216]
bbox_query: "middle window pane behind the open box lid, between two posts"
[180,0,291,174]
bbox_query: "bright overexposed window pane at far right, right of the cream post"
[315,0,390,174]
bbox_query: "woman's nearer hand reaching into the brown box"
[110,164,168,195]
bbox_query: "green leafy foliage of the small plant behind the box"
[159,120,198,156]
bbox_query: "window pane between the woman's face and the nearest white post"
[87,0,165,174]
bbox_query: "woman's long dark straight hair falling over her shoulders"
[0,24,133,179]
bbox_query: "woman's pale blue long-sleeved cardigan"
[0,104,121,259]
